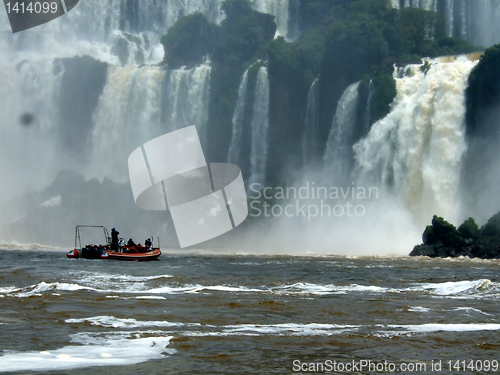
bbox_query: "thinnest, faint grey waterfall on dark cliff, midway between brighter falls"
[302,78,318,166]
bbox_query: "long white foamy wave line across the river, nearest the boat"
[0,275,500,300]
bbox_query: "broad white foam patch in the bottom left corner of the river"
[0,334,175,372]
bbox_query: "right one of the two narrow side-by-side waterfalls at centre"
[248,66,269,187]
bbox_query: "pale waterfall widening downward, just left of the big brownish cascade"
[323,82,359,181]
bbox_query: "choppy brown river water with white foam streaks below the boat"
[0,250,500,374]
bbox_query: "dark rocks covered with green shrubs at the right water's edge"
[410,212,500,259]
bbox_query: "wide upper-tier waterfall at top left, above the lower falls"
[0,0,224,65]
